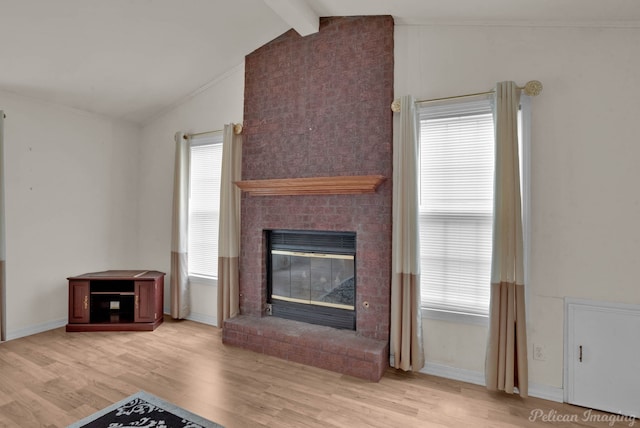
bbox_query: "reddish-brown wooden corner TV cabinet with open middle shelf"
[67,270,164,331]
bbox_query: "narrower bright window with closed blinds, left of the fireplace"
[188,134,222,283]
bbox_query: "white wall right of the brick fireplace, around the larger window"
[395,25,640,398]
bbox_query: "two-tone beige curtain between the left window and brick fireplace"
[217,124,242,327]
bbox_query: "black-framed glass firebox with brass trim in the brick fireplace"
[266,230,356,330]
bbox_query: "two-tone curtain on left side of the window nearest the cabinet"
[170,132,190,319]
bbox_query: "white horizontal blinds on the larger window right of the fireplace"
[418,98,494,315]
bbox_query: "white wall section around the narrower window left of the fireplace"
[138,64,244,325]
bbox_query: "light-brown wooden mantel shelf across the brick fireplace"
[235,175,386,196]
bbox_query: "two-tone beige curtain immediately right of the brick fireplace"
[390,96,424,371]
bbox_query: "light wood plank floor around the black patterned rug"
[0,320,629,428]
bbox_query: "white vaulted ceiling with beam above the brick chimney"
[0,0,640,123]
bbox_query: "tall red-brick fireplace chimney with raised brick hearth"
[223,16,394,380]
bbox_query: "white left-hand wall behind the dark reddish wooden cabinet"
[0,92,140,339]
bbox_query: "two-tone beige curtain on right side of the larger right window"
[485,82,528,397]
